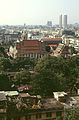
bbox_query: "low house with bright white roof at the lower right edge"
[53,92,79,109]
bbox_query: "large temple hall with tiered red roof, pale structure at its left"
[9,31,46,58]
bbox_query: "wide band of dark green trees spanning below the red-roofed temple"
[0,51,79,96]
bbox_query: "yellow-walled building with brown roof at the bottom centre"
[21,98,64,120]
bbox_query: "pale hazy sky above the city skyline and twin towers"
[0,0,79,25]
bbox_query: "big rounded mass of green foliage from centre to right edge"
[33,56,79,96]
